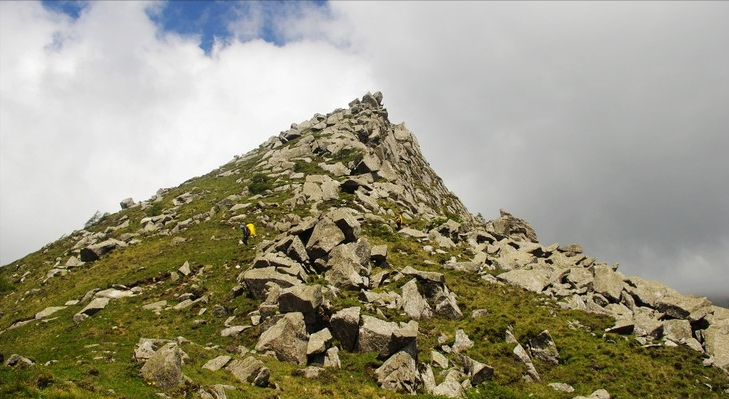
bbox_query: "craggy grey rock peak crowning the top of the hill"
[236,92,473,228]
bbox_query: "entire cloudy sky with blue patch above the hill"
[0,1,729,296]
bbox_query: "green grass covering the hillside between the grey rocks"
[0,135,729,399]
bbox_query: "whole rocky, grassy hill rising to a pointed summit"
[0,92,729,399]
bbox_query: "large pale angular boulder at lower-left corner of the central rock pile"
[256,312,309,366]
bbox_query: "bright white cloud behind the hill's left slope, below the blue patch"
[0,2,371,264]
